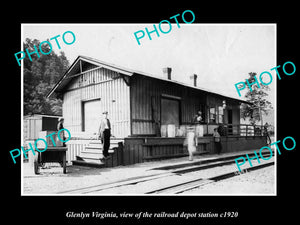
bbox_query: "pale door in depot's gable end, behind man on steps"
[82,99,102,133]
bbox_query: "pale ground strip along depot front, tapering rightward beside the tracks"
[22,149,274,195]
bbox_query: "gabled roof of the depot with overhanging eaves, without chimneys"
[47,55,251,104]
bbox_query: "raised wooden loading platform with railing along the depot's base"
[67,124,266,167]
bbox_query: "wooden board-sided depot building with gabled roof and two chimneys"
[48,56,266,166]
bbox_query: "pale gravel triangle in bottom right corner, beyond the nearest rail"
[184,166,275,195]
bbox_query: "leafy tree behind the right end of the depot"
[241,72,273,125]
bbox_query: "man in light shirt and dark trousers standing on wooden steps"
[99,111,111,158]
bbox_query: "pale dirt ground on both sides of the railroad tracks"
[21,151,275,195]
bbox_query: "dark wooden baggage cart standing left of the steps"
[34,146,68,174]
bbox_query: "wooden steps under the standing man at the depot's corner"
[72,139,123,167]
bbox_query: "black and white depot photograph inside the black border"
[21,22,276,195]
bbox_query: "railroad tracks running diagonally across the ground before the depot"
[59,153,274,194]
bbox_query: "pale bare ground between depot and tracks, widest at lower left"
[23,156,205,195]
